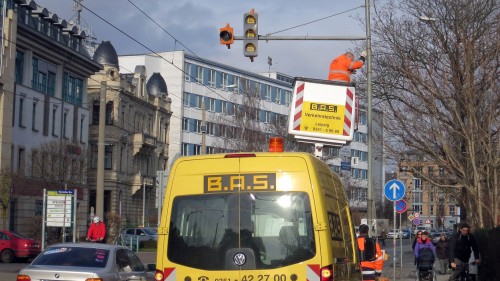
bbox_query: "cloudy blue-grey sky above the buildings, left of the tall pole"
[35,0,365,79]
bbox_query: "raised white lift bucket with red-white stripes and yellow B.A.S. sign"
[288,78,358,151]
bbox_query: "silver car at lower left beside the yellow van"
[17,243,155,281]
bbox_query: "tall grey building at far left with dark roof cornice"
[0,0,102,237]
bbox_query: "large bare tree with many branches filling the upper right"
[372,0,500,227]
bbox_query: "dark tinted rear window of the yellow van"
[167,191,316,270]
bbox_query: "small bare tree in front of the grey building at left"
[28,140,88,188]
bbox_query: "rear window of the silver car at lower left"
[32,247,109,268]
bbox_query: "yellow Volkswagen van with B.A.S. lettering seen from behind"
[155,143,361,281]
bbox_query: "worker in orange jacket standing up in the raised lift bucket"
[328,51,366,83]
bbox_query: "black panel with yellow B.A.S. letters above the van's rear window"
[203,173,276,193]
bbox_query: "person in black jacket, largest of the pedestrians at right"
[448,223,481,281]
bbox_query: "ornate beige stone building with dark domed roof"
[88,41,172,226]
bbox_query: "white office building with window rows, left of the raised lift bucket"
[119,51,292,163]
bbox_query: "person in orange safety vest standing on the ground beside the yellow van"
[357,224,384,281]
